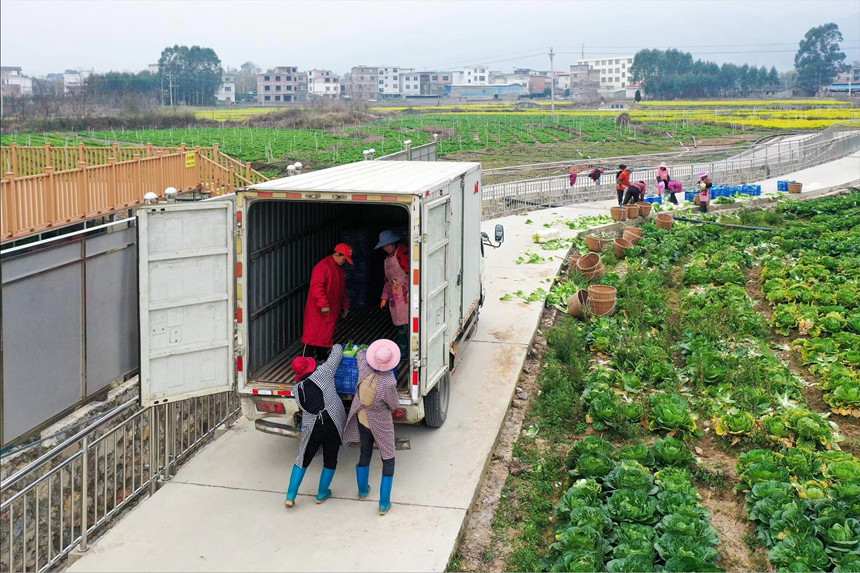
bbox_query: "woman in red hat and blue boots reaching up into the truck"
[284,344,346,507]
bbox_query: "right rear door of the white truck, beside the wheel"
[422,195,451,399]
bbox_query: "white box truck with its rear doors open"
[138,161,504,436]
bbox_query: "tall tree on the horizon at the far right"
[794,23,845,92]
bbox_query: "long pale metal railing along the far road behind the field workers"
[482,120,860,219]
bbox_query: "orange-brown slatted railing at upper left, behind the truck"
[0,144,267,241]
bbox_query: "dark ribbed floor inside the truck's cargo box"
[250,308,409,393]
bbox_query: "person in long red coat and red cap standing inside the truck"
[302,243,352,362]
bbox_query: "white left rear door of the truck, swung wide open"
[137,201,235,407]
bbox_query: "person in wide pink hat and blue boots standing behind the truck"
[343,339,400,515]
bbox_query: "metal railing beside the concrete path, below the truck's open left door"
[0,386,239,571]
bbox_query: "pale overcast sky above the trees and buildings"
[0,0,860,76]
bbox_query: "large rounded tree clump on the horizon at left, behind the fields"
[158,45,223,105]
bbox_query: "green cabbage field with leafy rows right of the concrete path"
[493,190,860,572]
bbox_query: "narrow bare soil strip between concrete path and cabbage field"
[457,308,558,571]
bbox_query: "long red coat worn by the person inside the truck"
[302,255,349,348]
